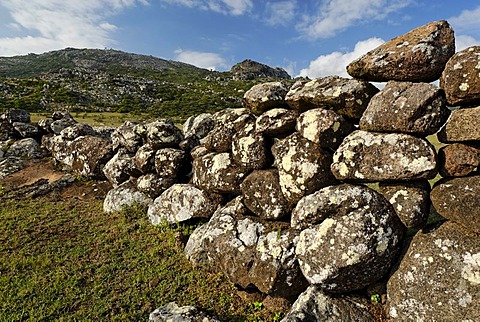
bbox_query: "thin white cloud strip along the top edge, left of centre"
[160,0,253,16]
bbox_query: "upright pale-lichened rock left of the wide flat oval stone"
[272,133,335,205]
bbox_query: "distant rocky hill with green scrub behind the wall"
[0,48,290,119]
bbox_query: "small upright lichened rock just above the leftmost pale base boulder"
[102,148,134,187]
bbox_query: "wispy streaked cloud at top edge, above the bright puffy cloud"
[297,0,412,39]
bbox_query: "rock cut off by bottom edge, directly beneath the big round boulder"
[281,286,376,322]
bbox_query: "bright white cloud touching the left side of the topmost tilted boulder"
[299,38,384,78]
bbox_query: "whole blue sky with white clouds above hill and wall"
[0,0,480,78]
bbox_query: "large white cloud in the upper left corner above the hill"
[0,0,148,56]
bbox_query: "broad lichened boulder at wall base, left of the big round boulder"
[185,197,307,298]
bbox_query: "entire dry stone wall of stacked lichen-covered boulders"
[0,21,480,321]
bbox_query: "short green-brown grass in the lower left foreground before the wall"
[0,189,281,321]
